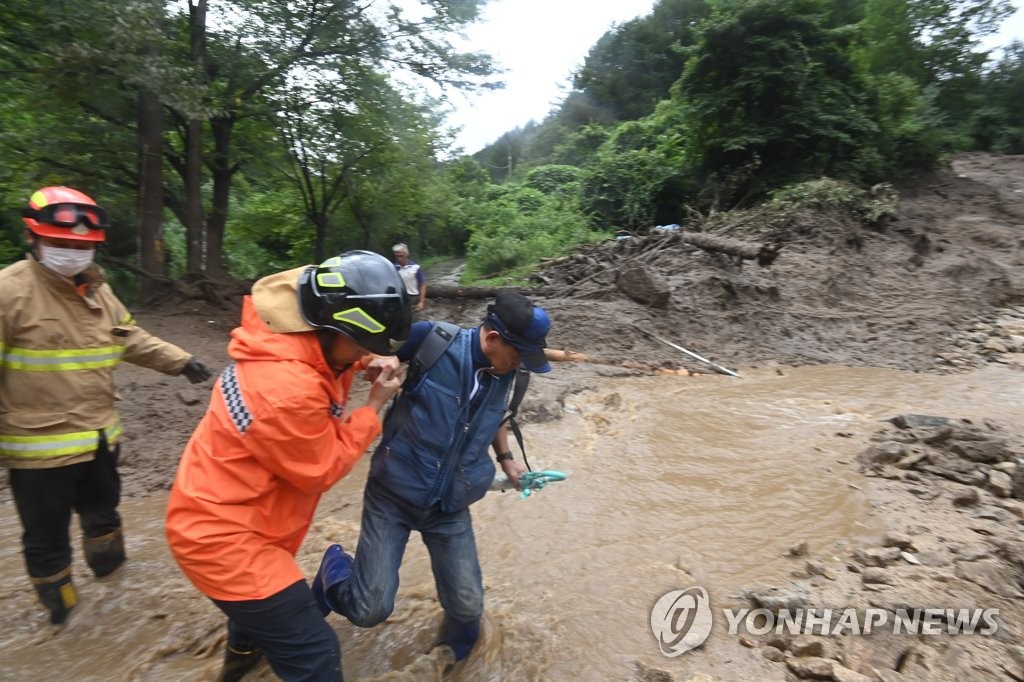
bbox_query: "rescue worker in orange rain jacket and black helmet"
[166,251,412,682]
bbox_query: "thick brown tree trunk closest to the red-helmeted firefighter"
[138,83,166,302]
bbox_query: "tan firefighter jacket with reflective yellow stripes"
[0,255,190,469]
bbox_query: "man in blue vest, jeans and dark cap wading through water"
[312,292,551,660]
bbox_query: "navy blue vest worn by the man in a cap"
[370,329,515,513]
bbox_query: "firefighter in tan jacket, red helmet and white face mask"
[0,186,210,624]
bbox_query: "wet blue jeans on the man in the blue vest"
[333,479,483,640]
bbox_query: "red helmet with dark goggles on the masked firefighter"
[22,187,110,242]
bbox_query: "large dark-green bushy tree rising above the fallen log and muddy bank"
[675,0,873,205]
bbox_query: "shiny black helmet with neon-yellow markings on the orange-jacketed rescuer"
[299,251,413,355]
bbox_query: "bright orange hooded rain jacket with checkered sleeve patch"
[166,296,381,601]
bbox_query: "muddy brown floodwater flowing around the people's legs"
[0,367,1024,680]
